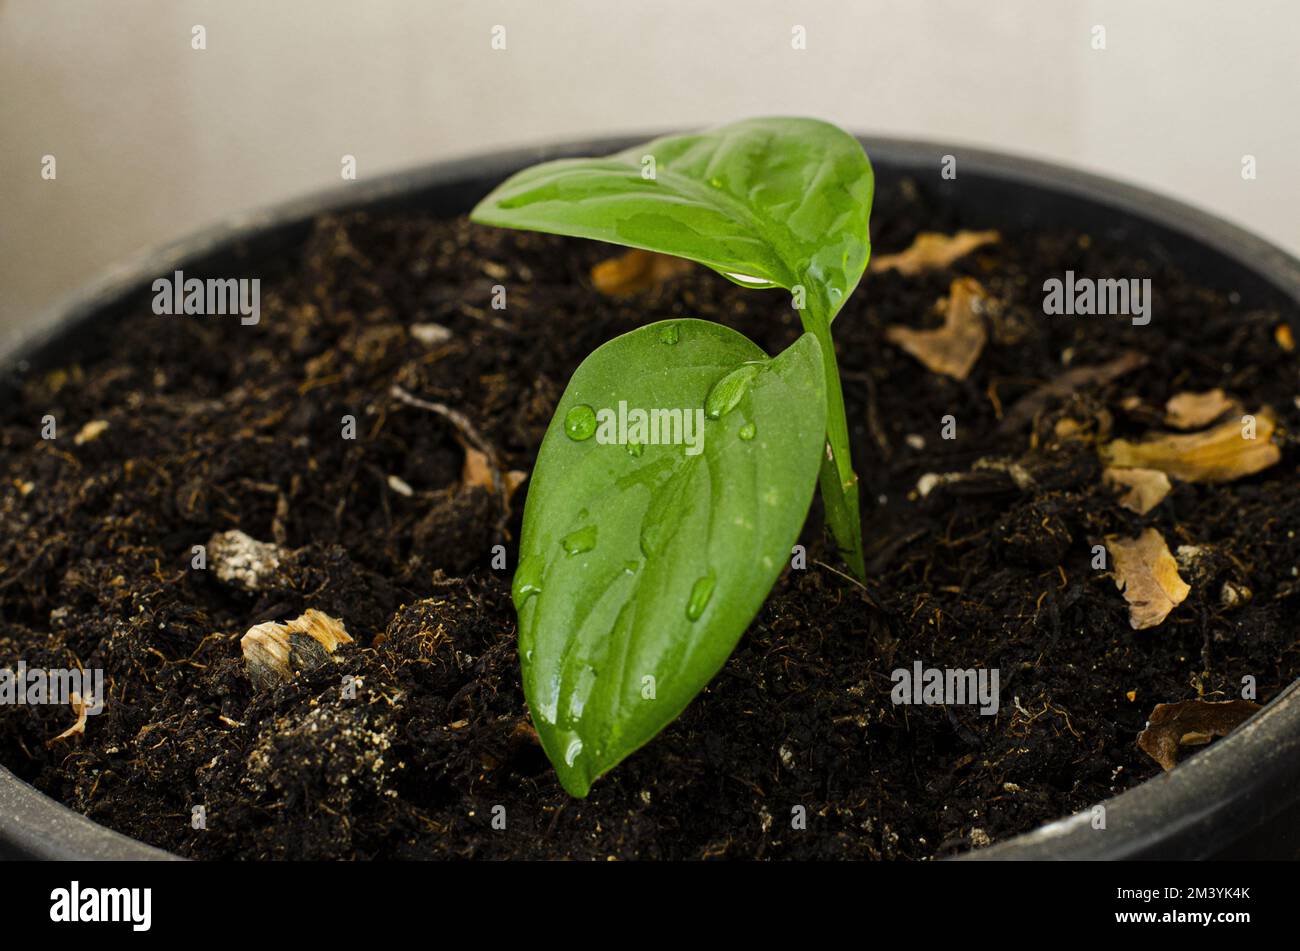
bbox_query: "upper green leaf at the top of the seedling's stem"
[471,118,874,323]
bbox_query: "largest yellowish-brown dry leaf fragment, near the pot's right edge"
[1101,409,1282,482]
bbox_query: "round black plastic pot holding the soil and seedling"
[0,136,1300,859]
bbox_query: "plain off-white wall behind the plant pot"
[0,0,1300,334]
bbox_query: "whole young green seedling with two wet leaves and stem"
[471,118,874,796]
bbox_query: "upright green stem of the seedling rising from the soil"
[800,311,867,581]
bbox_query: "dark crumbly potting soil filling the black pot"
[0,172,1300,859]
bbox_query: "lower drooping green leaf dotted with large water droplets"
[514,320,826,796]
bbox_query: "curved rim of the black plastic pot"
[0,134,1300,860]
